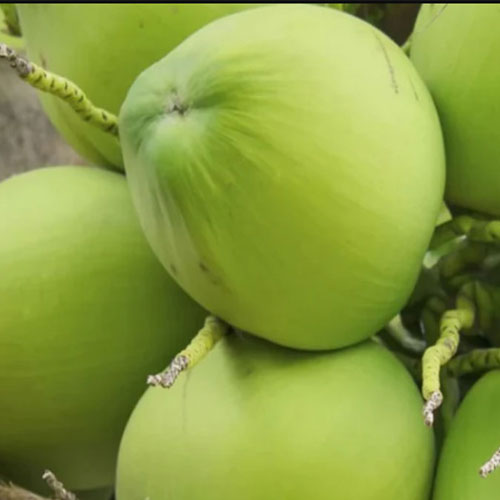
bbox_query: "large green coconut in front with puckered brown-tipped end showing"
[120,5,444,349]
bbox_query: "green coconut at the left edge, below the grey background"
[0,167,205,496]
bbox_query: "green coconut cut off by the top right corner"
[411,4,500,216]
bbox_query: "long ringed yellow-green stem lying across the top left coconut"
[0,44,118,136]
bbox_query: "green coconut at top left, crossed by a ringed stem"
[18,3,256,166]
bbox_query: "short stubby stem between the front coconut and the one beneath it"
[147,316,229,388]
